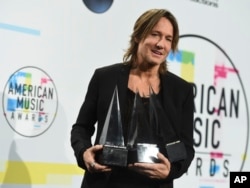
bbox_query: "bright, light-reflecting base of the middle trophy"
[128,143,159,163]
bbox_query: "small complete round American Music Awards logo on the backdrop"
[2,66,58,137]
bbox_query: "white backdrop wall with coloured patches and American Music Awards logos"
[0,0,250,188]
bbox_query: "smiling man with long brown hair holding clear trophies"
[71,9,194,188]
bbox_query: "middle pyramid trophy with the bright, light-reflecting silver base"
[127,89,159,163]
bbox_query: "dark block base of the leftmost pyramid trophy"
[98,145,128,167]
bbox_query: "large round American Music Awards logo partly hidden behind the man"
[167,35,249,188]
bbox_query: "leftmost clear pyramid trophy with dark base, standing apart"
[98,87,128,166]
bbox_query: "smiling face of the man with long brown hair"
[137,17,173,66]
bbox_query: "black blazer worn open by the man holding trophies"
[71,63,194,188]
